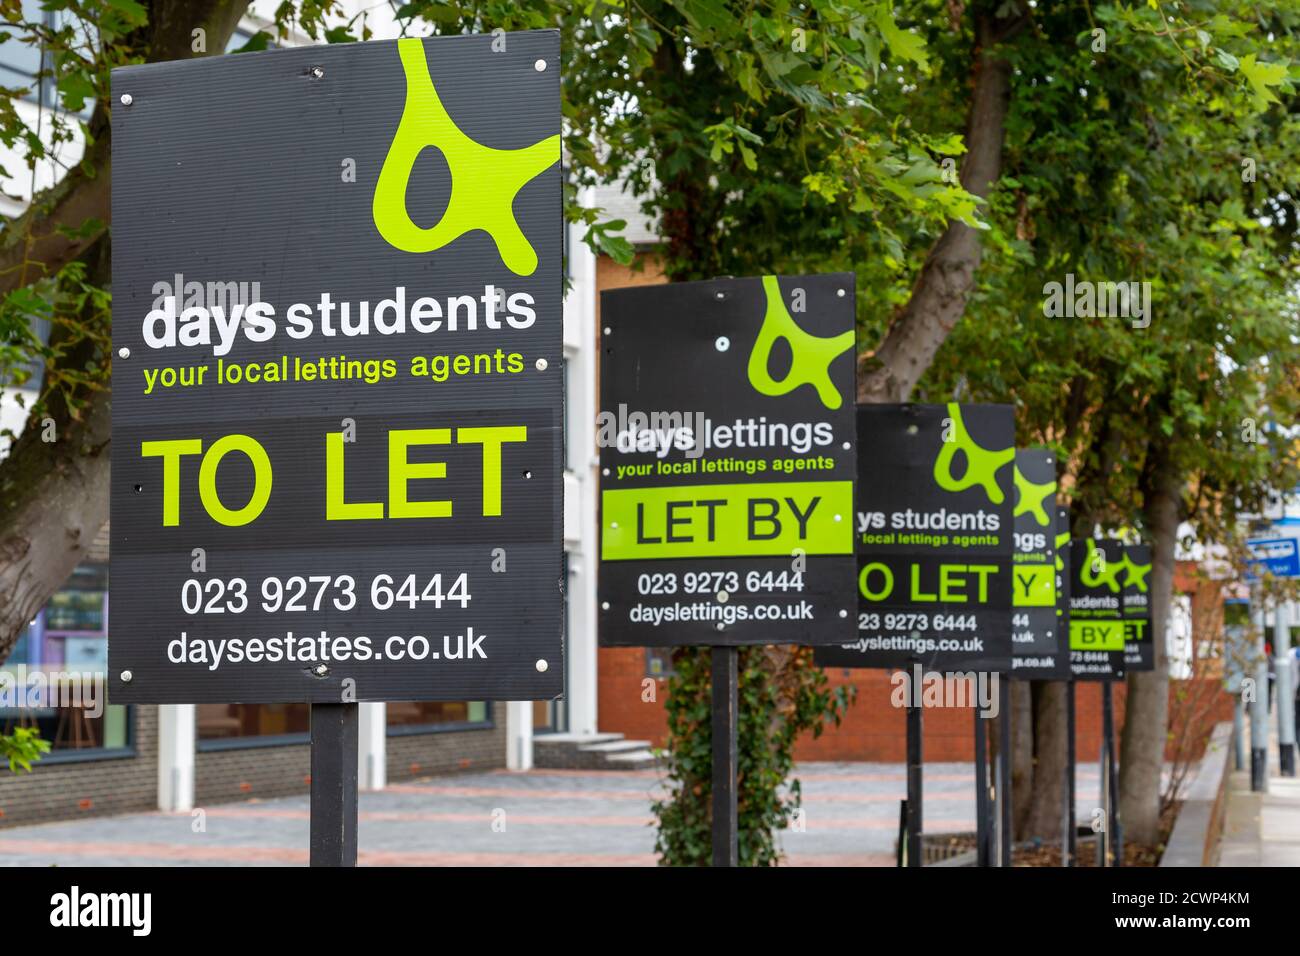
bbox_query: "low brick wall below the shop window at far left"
[0,705,159,826]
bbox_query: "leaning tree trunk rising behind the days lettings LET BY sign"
[858,1,1028,405]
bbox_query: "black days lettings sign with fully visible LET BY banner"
[598,273,857,646]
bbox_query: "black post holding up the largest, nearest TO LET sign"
[311,704,360,866]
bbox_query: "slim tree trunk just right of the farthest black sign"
[1119,449,1182,845]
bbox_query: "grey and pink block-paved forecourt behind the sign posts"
[0,763,1096,866]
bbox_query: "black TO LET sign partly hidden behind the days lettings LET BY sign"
[816,402,1015,671]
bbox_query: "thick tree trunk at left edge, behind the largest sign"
[0,0,248,662]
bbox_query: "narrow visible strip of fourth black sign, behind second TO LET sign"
[1011,449,1070,680]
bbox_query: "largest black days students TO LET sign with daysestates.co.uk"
[109,31,564,702]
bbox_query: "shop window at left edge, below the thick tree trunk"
[0,562,134,762]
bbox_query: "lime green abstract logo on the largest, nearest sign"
[372,38,560,276]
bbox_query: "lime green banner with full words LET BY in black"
[601,481,853,561]
